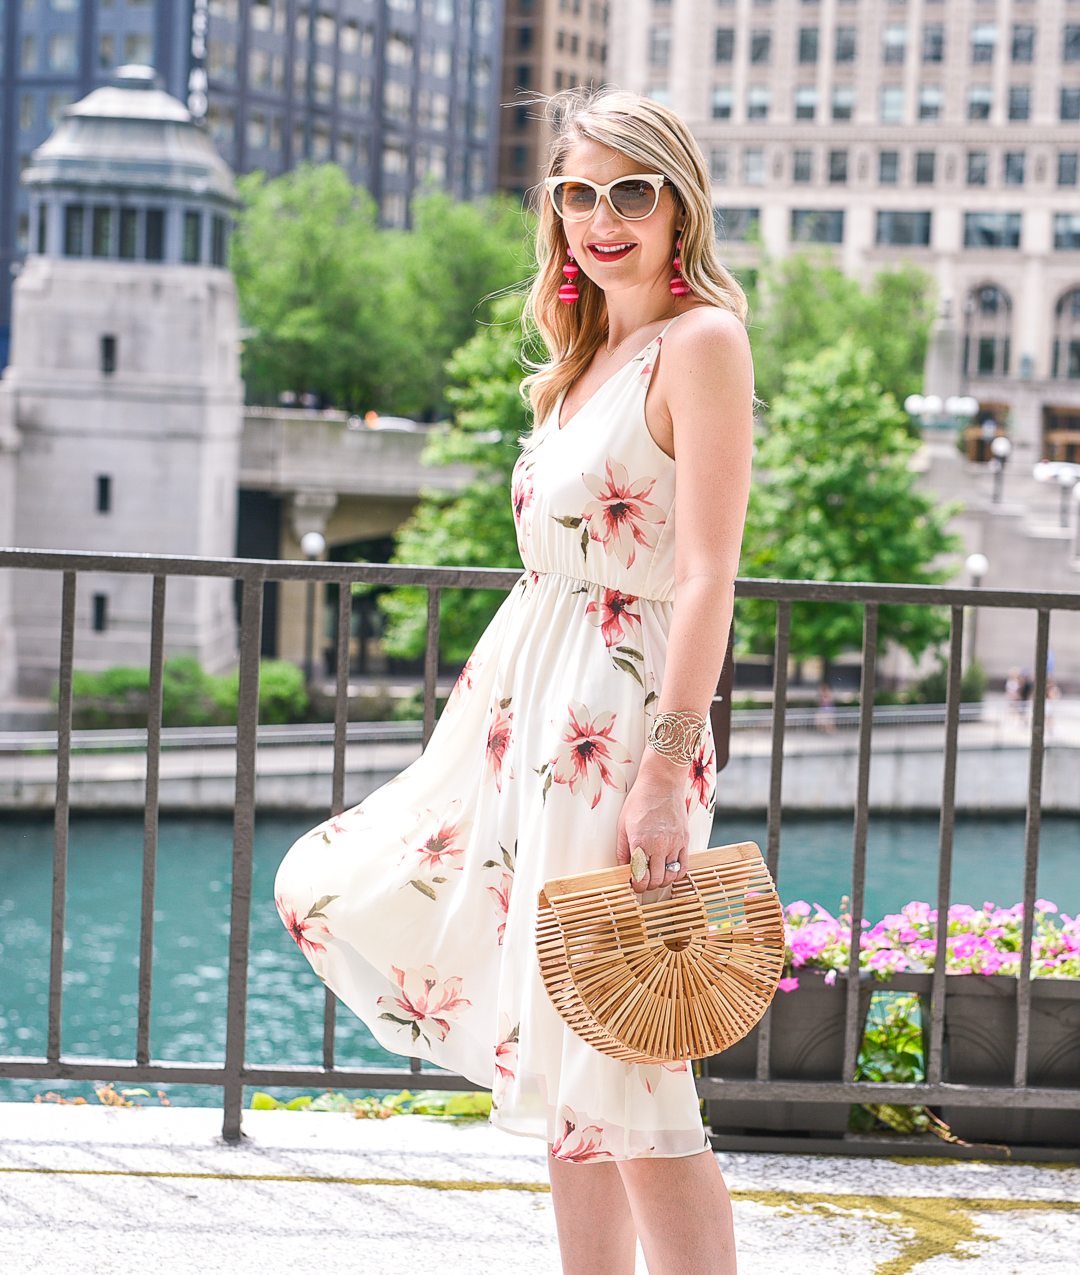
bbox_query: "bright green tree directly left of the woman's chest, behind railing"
[379,302,529,660]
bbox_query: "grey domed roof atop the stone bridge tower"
[23,66,238,204]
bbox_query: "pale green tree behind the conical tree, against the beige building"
[745,252,933,415]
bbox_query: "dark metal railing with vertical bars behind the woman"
[0,550,1080,1141]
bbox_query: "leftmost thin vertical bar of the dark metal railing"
[46,571,77,1062]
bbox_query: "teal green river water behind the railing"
[0,817,1080,1105]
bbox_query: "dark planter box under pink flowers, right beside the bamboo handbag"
[703,969,876,1137]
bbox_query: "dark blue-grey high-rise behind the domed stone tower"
[0,0,502,365]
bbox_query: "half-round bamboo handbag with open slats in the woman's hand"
[537,842,784,1063]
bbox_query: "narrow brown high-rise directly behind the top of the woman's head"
[499,0,608,199]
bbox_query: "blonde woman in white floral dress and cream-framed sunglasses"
[277,91,754,1275]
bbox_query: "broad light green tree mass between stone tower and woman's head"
[233,164,527,419]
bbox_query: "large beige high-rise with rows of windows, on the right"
[609,0,1080,463]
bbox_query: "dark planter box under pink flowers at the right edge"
[941,974,1080,1146]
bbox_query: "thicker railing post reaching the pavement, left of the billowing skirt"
[222,572,263,1142]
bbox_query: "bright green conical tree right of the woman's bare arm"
[736,337,959,659]
